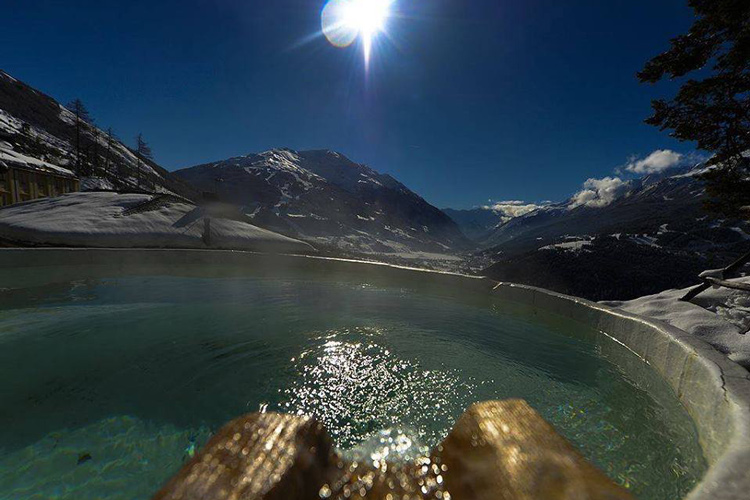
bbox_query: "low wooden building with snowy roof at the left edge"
[0,157,81,207]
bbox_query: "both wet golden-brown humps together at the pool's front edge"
[154,400,633,500]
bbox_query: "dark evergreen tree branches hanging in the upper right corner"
[638,0,750,217]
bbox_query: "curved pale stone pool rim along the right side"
[493,282,750,500]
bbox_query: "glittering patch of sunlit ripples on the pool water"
[278,327,475,448]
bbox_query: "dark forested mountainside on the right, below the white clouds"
[482,166,750,300]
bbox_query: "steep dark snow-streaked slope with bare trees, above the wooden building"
[0,70,195,198]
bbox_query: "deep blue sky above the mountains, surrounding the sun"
[0,0,692,208]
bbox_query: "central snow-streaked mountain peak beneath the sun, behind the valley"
[175,149,469,254]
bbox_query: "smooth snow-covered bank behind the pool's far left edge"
[0,192,314,253]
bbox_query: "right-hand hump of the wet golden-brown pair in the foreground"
[435,400,633,500]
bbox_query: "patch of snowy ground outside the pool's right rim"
[603,276,750,368]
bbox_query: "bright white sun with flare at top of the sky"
[321,0,394,63]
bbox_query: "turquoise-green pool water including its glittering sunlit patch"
[0,275,706,500]
